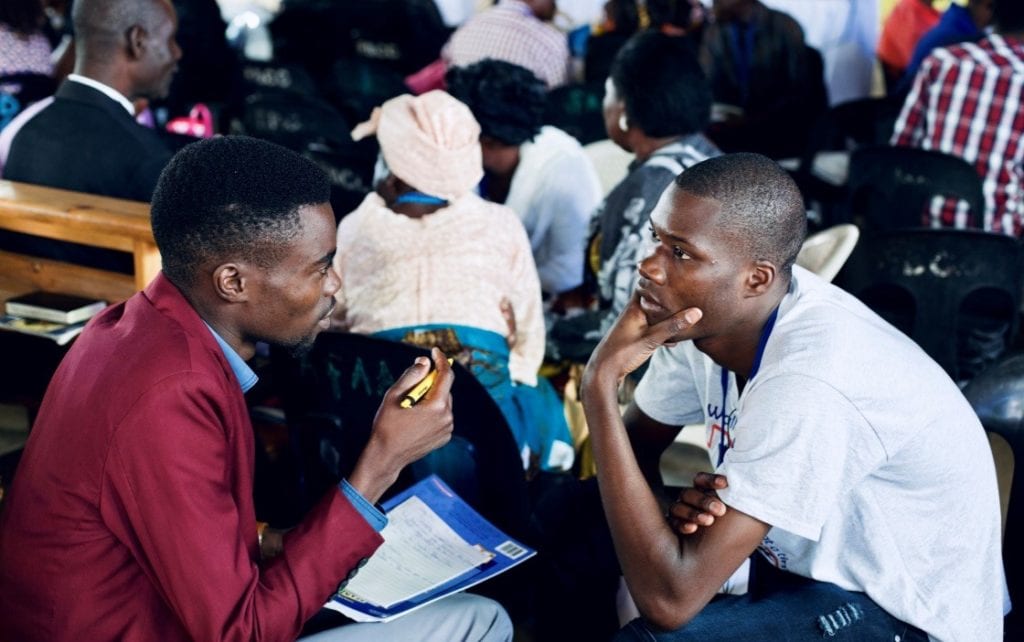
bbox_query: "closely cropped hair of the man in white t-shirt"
[675,153,807,277]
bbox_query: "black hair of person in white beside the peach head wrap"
[444,58,548,145]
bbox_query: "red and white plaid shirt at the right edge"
[892,35,1024,237]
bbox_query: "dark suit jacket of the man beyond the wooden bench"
[0,81,172,272]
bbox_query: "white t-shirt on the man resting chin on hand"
[635,266,1006,642]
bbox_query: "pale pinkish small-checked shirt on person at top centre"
[441,0,569,89]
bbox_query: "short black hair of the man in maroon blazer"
[151,136,331,290]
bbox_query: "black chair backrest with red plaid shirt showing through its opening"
[847,145,985,231]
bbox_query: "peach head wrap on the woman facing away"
[352,90,483,201]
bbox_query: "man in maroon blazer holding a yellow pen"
[0,137,511,641]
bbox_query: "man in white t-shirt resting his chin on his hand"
[583,154,1005,642]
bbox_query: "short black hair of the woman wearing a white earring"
[610,31,712,138]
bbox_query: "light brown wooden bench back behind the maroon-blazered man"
[0,180,160,303]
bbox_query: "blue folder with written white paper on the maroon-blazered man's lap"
[326,475,535,622]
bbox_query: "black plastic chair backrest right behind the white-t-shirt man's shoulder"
[842,228,1024,380]
